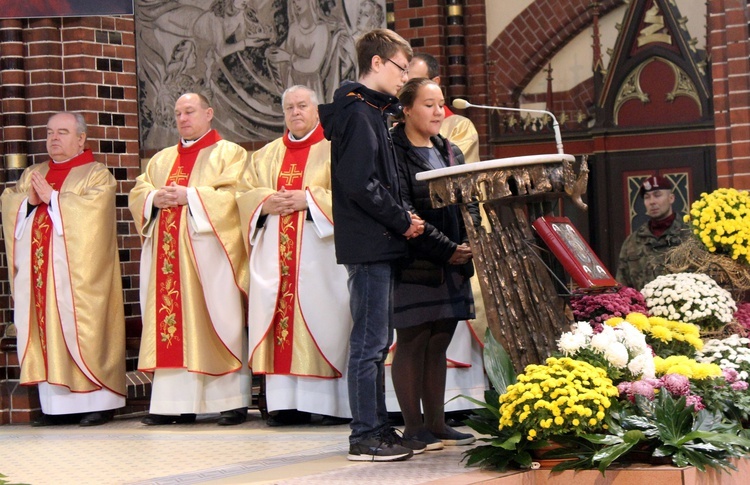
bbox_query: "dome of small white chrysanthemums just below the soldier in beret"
[641,273,737,330]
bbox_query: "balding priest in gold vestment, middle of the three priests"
[129,93,251,425]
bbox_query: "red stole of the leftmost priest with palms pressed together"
[31,150,95,362]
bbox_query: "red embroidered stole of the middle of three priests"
[155,130,221,368]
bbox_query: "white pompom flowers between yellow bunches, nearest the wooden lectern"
[557,321,655,382]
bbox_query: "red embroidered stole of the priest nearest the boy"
[272,124,324,375]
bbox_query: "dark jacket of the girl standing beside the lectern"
[391,124,481,264]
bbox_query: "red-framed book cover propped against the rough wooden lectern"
[531,216,619,288]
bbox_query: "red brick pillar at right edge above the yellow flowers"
[707,0,750,189]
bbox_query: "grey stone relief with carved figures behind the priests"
[135,0,385,150]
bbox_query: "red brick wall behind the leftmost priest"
[0,16,140,423]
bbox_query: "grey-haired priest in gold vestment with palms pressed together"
[2,113,126,426]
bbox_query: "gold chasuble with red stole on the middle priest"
[129,130,247,376]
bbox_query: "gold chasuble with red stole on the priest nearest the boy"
[237,125,351,378]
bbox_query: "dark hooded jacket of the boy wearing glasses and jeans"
[318,82,411,264]
